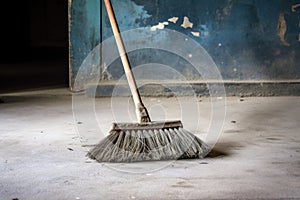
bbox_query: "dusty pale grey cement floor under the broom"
[0,89,300,200]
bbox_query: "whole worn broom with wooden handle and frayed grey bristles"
[87,0,210,162]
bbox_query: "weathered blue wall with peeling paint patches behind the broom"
[69,0,300,91]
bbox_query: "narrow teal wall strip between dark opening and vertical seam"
[69,0,101,89]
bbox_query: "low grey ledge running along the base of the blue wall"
[86,80,300,97]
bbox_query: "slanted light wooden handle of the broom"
[104,0,151,123]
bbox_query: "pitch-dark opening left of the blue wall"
[0,0,68,93]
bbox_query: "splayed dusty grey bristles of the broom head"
[87,128,210,162]
